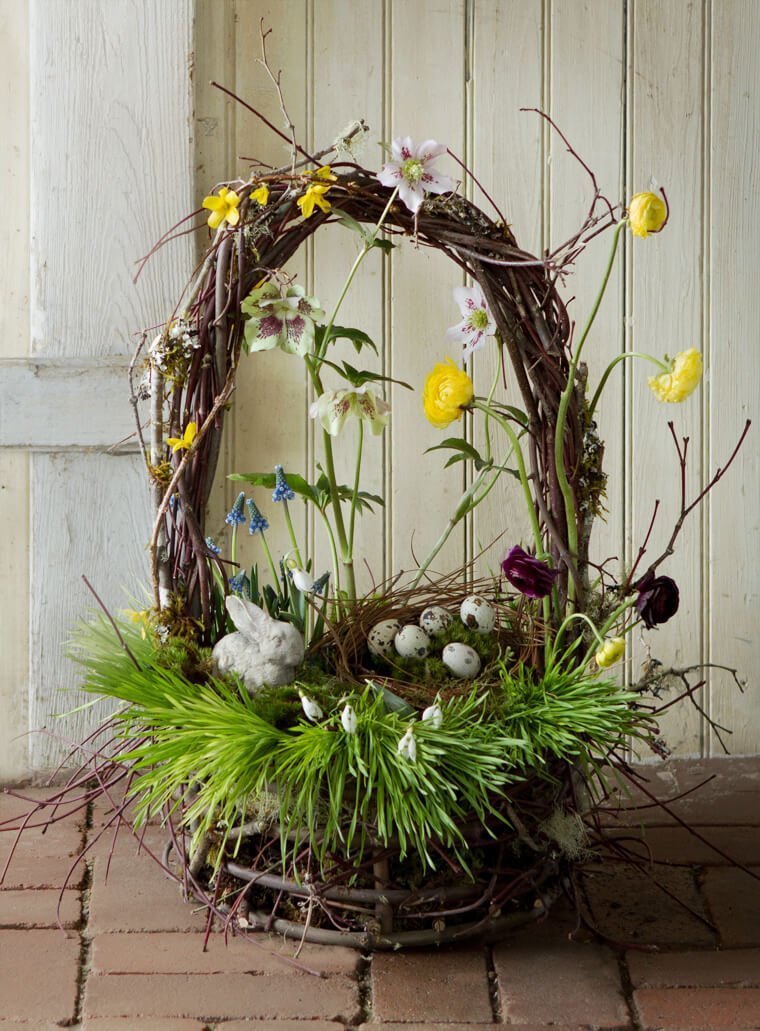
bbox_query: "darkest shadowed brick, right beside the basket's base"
[584,863,720,946]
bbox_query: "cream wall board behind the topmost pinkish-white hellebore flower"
[386,0,466,572]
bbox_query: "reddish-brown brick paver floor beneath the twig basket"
[0,759,760,1031]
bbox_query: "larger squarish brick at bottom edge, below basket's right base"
[494,942,629,1028]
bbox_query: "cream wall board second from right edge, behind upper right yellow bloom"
[627,0,704,755]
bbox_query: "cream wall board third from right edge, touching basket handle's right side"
[547,0,626,593]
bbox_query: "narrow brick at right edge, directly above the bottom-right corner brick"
[626,949,760,988]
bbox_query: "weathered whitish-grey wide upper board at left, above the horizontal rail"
[30,0,192,356]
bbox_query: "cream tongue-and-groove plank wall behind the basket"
[196,0,760,755]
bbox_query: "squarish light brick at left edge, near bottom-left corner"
[0,931,79,1023]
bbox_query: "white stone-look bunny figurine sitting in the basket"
[211,594,303,695]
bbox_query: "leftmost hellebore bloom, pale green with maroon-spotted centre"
[240,282,325,357]
